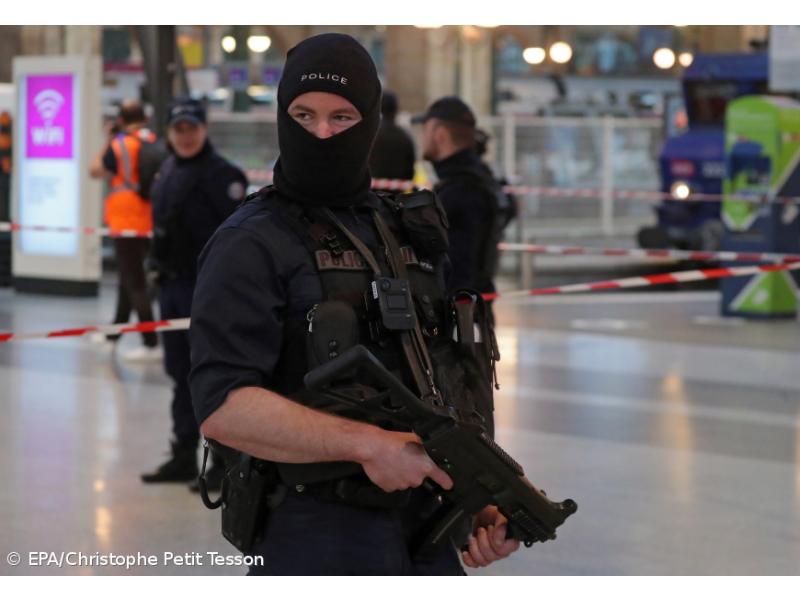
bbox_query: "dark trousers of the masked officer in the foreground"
[248,491,464,575]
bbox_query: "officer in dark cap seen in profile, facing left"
[412,96,502,293]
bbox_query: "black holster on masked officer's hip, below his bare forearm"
[222,454,285,554]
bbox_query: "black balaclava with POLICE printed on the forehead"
[273,33,381,206]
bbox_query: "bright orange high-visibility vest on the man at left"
[105,129,155,233]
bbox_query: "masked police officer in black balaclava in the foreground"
[190,34,519,574]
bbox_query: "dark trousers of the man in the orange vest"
[108,238,158,348]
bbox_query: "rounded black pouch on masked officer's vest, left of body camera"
[306,300,359,370]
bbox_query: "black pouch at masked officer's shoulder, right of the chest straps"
[392,190,450,257]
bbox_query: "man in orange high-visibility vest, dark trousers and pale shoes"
[89,100,162,360]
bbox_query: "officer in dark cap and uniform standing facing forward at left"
[142,99,247,488]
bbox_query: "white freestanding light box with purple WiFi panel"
[12,56,102,294]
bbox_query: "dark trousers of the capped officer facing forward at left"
[158,279,200,446]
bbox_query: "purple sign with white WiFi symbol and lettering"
[25,75,74,158]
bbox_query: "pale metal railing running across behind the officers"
[210,113,663,241]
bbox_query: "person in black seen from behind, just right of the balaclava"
[369,90,416,181]
